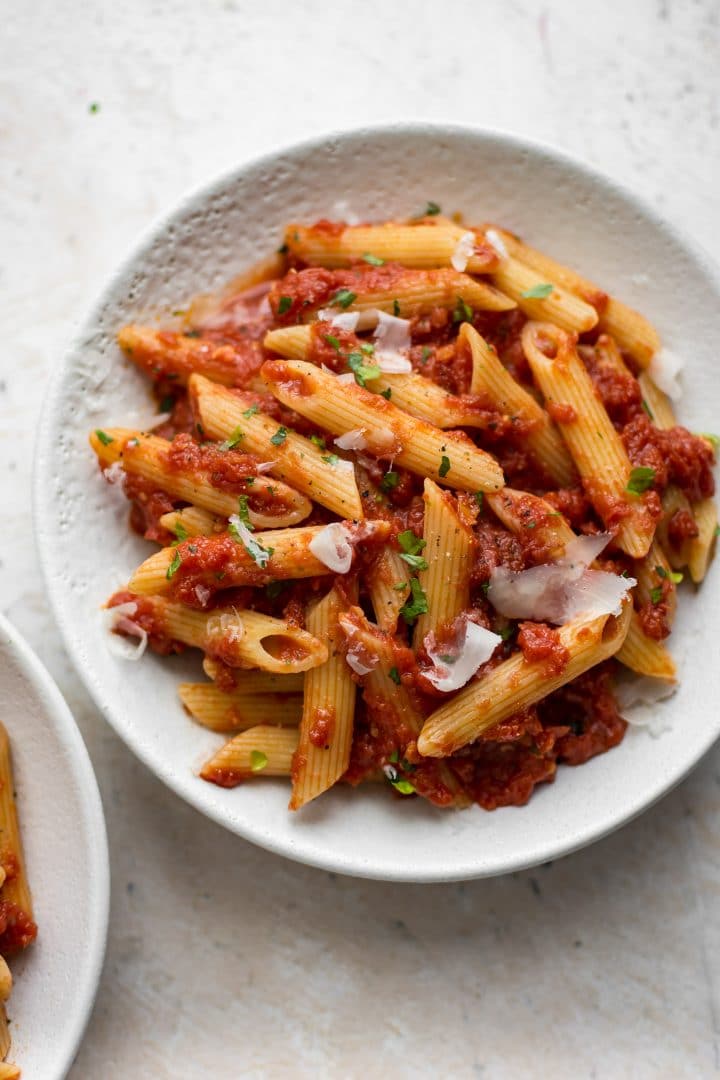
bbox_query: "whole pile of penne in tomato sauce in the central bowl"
[91,210,717,810]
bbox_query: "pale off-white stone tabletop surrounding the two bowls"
[0,0,720,1080]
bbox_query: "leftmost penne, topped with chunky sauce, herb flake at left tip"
[90,428,312,528]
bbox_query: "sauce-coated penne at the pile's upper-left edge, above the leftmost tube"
[118,325,255,387]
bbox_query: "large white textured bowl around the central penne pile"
[35,124,720,881]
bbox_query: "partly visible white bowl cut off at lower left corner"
[0,616,110,1080]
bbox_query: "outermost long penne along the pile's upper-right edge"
[493,227,660,367]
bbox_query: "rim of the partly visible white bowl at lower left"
[0,613,110,1080]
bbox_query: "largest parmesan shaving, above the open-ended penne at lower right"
[488,532,637,625]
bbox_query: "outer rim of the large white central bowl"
[32,120,720,883]
